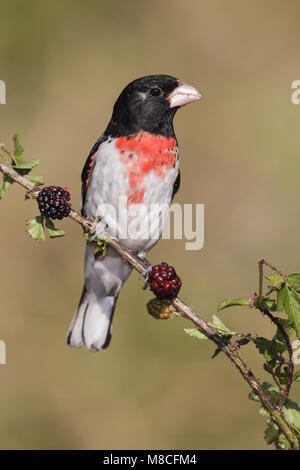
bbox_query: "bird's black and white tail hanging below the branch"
[67,243,132,351]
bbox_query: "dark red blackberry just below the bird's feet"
[148,263,181,300]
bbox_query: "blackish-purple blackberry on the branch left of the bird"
[37,186,71,220]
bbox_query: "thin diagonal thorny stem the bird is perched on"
[0,156,299,450]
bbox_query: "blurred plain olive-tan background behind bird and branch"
[0,0,300,449]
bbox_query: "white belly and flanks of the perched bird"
[85,140,179,251]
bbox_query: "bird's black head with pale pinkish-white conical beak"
[105,75,201,137]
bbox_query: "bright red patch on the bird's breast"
[116,131,176,204]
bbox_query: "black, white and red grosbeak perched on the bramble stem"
[67,75,201,351]
